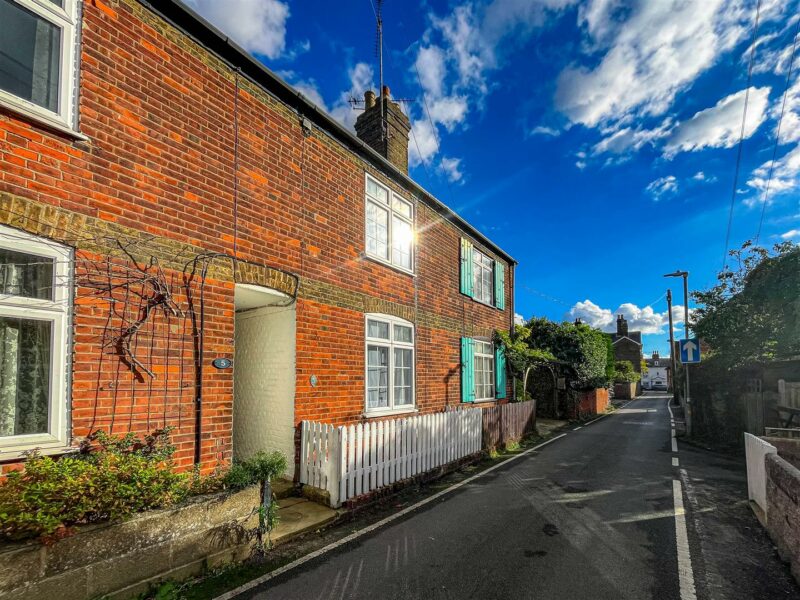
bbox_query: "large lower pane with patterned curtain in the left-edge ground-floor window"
[0,317,52,437]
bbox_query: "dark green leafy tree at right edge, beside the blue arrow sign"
[692,242,800,367]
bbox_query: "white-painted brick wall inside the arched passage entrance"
[233,304,296,472]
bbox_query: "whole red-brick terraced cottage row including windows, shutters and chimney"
[0,0,515,472]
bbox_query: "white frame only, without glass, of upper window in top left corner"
[0,0,80,133]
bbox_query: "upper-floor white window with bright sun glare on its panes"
[366,175,414,272]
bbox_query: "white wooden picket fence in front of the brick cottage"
[300,409,482,507]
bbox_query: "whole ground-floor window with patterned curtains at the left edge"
[0,227,72,458]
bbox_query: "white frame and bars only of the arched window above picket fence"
[364,313,417,417]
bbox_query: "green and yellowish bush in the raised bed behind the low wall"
[0,429,286,541]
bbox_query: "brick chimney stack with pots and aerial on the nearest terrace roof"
[356,85,411,174]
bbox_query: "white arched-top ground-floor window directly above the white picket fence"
[366,315,414,415]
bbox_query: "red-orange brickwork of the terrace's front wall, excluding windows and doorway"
[0,0,513,470]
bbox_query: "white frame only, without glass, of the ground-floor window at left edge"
[0,225,73,459]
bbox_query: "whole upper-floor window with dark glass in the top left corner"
[0,0,78,128]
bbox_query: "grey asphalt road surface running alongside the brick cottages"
[240,394,800,600]
